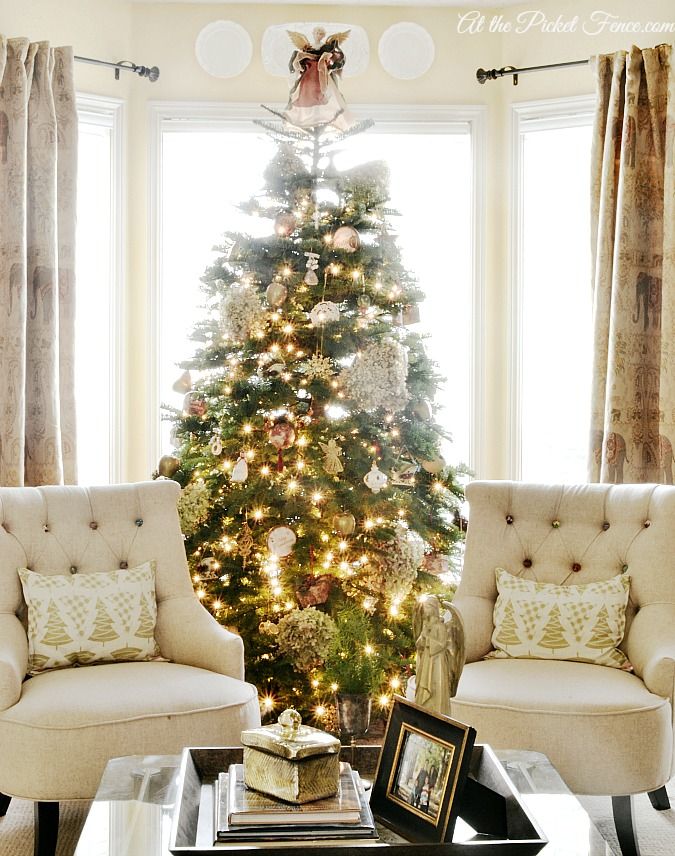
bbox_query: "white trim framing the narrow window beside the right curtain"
[506,95,597,481]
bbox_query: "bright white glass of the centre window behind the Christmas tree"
[159,125,473,463]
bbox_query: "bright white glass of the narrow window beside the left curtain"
[75,116,117,484]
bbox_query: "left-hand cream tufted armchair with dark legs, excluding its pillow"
[0,480,260,856]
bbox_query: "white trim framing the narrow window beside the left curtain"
[76,92,126,484]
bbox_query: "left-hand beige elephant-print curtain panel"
[0,36,77,485]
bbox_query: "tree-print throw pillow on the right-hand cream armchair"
[488,568,631,669]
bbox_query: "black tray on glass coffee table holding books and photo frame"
[169,744,547,856]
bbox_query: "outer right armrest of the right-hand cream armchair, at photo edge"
[622,603,675,701]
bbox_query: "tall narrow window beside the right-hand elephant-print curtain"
[510,98,594,483]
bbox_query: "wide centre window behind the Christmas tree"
[151,105,482,468]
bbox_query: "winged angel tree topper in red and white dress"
[283,27,354,131]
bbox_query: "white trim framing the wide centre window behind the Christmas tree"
[146,101,487,477]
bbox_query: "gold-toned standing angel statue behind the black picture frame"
[413,595,466,715]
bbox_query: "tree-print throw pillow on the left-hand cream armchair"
[19,562,159,675]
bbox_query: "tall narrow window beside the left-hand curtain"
[75,95,122,484]
